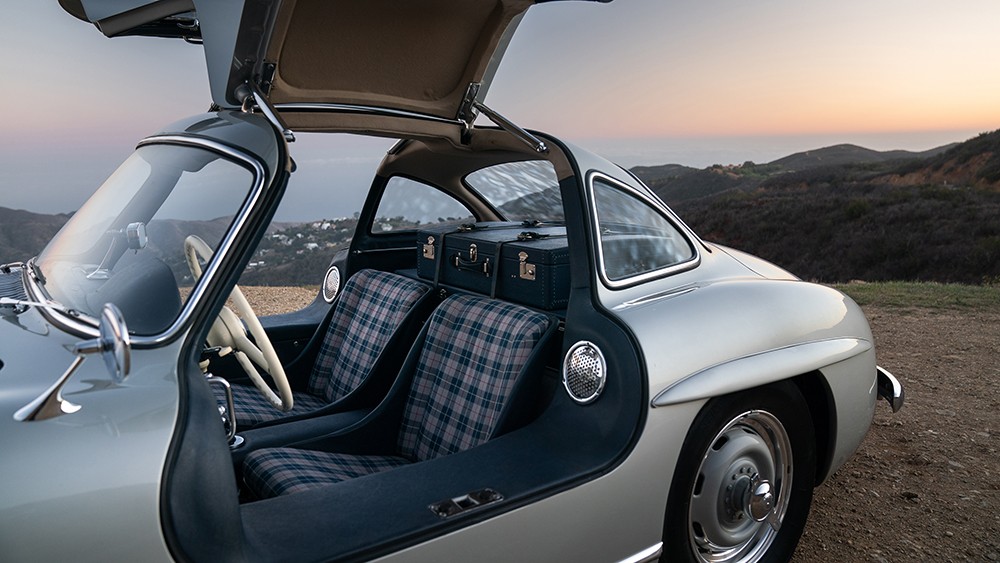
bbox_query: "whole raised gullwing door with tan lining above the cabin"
[59,0,610,124]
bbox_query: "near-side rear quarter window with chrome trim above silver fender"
[593,178,695,282]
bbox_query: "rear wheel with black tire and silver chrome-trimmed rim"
[663,382,816,563]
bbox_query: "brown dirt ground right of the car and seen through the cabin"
[244,287,1000,563]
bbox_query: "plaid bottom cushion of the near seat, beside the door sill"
[243,448,410,499]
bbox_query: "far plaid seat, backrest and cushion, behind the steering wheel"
[212,270,430,428]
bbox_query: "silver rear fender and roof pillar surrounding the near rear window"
[569,141,877,481]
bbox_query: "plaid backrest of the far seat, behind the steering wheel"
[307,270,430,403]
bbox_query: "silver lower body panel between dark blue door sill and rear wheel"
[372,401,704,563]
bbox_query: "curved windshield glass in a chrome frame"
[36,145,254,335]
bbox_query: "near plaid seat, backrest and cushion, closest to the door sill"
[243,295,550,498]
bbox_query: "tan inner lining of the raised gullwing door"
[266,0,532,118]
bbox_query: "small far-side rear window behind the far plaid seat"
[371,176,475,230]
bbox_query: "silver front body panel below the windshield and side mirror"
[0,310,178,561]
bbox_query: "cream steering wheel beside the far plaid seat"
[184,235,293,412]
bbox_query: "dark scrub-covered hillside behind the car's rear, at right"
[661,131,1000,283]
